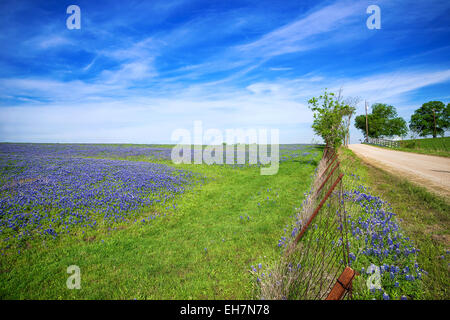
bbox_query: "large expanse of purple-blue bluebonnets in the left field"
[0,144,203,254]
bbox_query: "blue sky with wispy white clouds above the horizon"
[0,0,450,143]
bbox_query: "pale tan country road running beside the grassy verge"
[349,144,450,197]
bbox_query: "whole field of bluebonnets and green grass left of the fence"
[0,144,322,299]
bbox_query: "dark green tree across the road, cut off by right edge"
[409,101,450,138]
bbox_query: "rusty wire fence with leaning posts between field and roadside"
[261,148,355,300]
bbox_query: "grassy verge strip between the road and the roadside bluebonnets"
[340,149,450,299]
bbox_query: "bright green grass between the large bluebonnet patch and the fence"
[0,148,321,299]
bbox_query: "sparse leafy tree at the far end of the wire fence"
[308,90,353,148]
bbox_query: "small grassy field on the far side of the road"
[368,137,450,157]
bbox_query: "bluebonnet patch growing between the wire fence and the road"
[345,174,427,300]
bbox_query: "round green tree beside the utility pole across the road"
[355,103,408,138]
